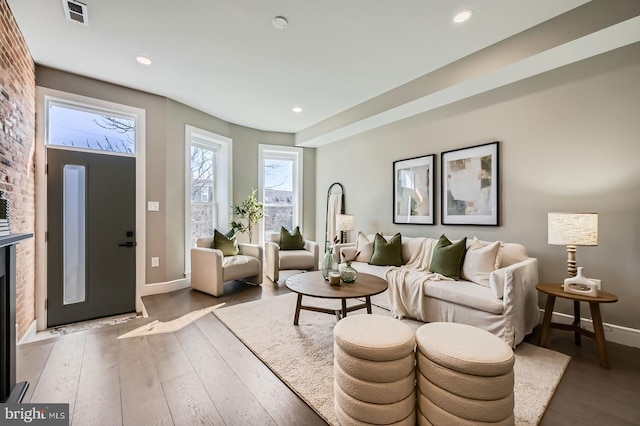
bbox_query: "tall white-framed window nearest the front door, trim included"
[185,126,231,274]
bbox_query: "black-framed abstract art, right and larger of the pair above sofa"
[440,141,500,226]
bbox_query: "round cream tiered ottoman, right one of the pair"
[416,322,515,426]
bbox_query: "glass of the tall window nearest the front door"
[190,145,216,247]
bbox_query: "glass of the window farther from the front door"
[264,158,294,241]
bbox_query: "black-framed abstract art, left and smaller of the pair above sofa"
[393,154,436,225]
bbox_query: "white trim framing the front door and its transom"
[34,86,147,330]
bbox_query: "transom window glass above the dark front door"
[47,103,136,154]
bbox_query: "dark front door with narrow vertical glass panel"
[47,148,136,327]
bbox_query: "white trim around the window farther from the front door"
[258,144,304,245]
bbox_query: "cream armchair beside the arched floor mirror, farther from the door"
[265,233,319,282]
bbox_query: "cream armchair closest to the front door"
[191,236,262,296]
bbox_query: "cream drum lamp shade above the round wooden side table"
[548,213,598,246]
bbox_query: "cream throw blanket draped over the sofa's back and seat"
[385,238,453,321]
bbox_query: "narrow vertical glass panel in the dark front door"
[62,164,86,305]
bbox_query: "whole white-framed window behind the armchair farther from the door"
[259,145,303,245]
